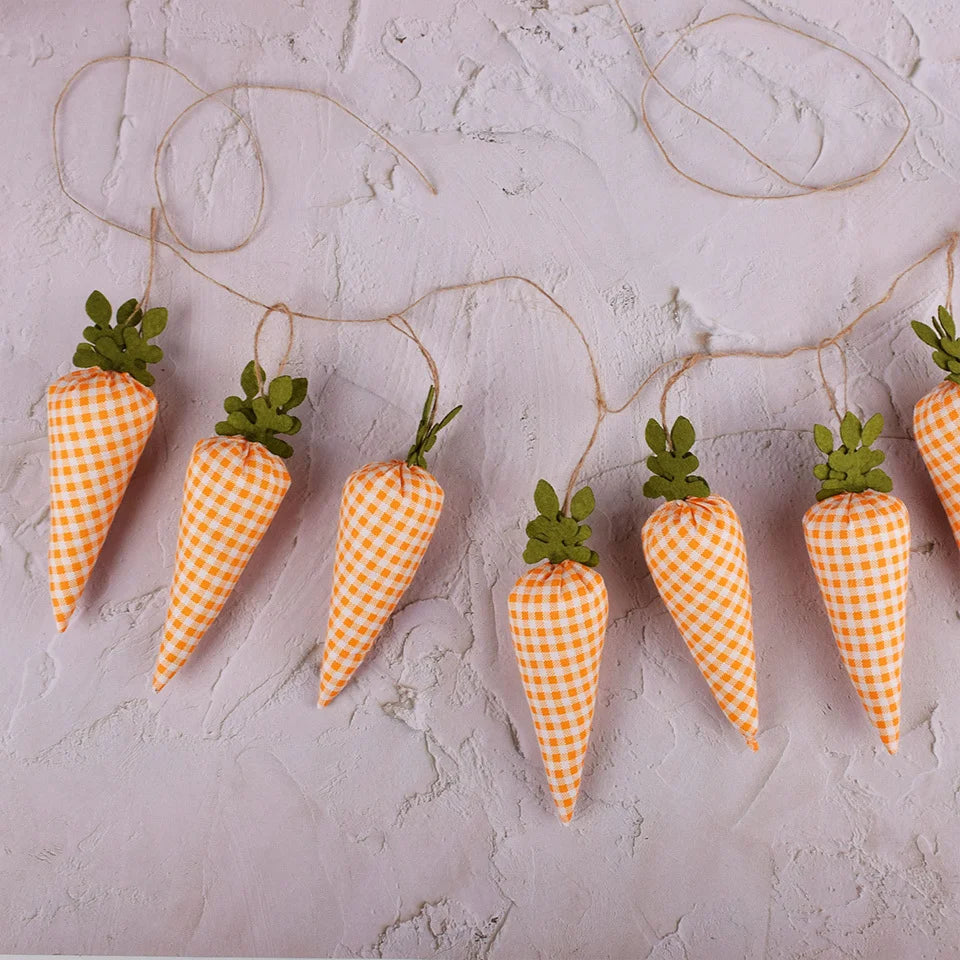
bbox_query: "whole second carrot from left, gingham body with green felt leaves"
[153,361,307,691]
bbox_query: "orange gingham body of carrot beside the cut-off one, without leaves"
[803,490,910,753]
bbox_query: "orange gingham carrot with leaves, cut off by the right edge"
[911,307,960,547]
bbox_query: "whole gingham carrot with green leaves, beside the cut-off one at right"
[803,413,910,753]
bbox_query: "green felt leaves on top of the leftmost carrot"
[73,290,167,387]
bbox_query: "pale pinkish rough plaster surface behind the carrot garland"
[0,0,960,960]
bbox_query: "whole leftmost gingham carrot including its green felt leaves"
[47,290,167,632]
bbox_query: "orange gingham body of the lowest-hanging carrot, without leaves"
[508,560,608,823]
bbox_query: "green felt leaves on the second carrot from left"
[215,360,307,458]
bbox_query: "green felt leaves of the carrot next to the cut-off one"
[813,410,893,500]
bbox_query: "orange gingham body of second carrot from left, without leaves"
[153,437,290,691]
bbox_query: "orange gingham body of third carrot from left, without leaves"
[318,460,443,707]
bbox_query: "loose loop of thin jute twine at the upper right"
[613,0,910,200]
